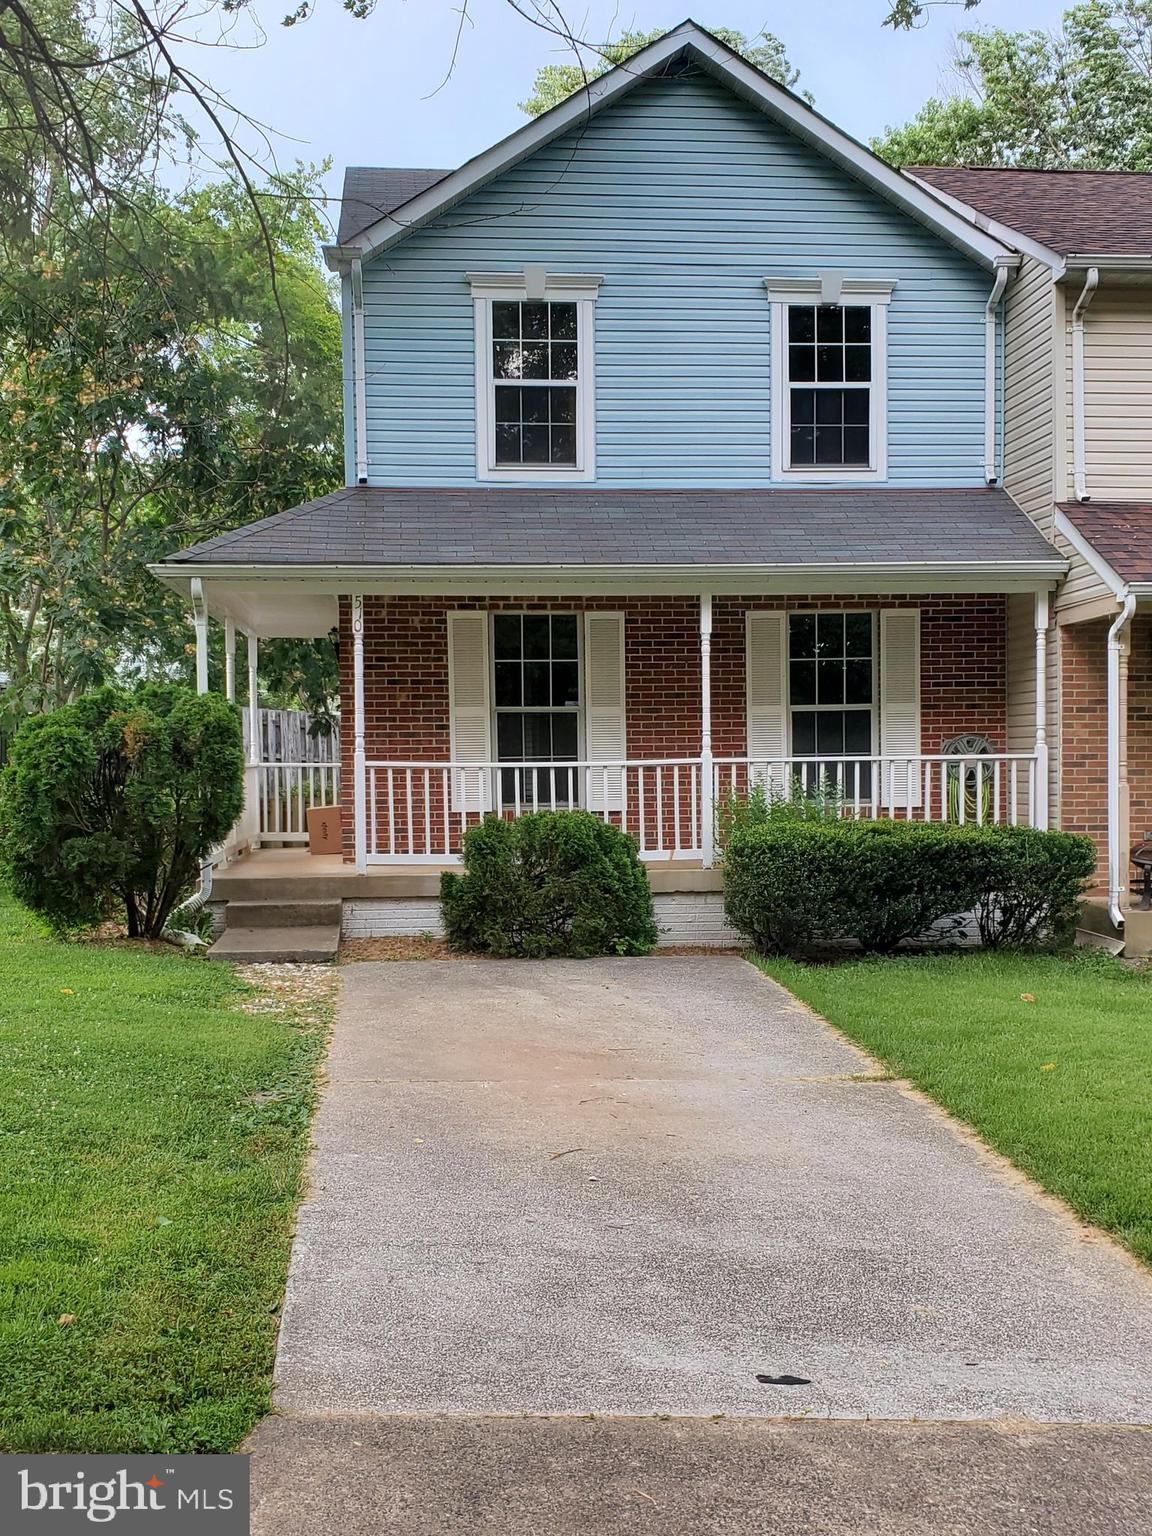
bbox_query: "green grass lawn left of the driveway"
[0,894,330,1453]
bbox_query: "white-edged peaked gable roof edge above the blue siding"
[324,22,1015,270]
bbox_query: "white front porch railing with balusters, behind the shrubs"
[356,753,1037,863]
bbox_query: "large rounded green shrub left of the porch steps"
[0,685,244,938]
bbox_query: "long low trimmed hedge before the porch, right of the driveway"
[723,817,1094,954]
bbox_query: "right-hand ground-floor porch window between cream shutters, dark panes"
[788,613,876,799]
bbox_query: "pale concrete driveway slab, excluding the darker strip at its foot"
[258,957,1152,1419]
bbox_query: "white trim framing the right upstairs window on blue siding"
[763,273,895,485]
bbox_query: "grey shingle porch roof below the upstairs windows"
[162,485,1060,567]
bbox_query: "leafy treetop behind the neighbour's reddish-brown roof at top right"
[872,0,1152,170]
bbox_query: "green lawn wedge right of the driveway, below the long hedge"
[759,952,1152,1263]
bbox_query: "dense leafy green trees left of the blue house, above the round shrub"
[0,174,339,714]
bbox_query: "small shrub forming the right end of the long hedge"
[975,826,1097,949]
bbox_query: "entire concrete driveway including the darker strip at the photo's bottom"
[250,957,1152,1536]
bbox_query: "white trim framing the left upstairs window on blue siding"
[468,267,604,485]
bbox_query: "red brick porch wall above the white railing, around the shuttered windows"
[339,594,1006,857]
